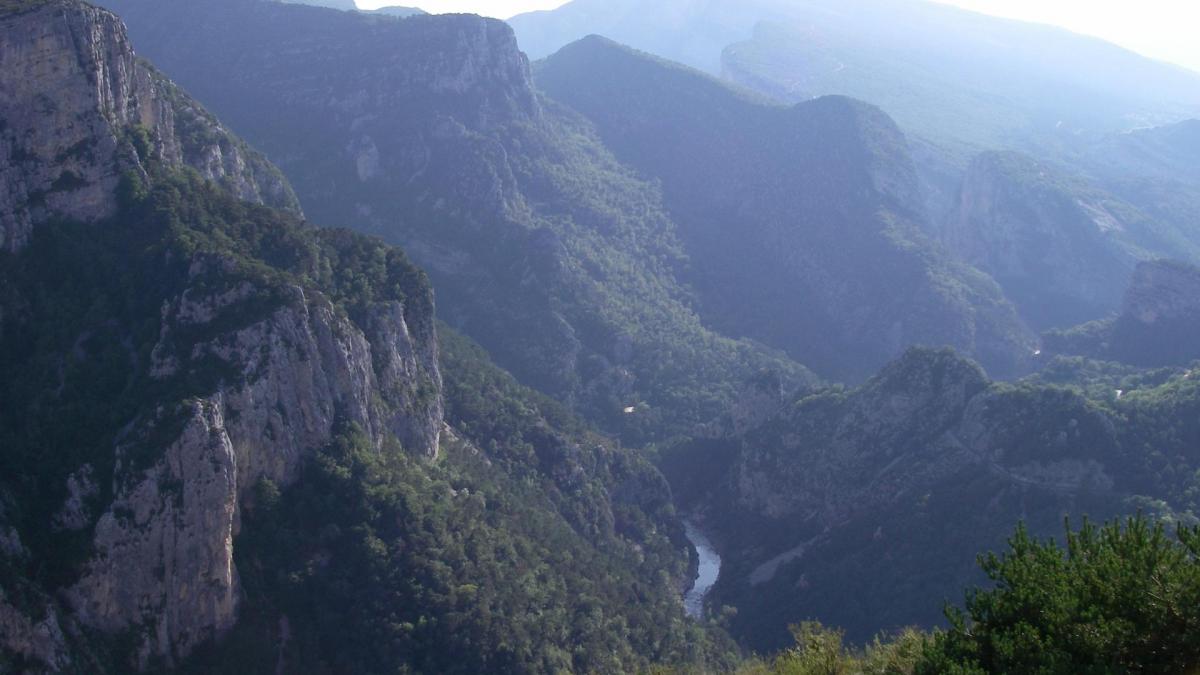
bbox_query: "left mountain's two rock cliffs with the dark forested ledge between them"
[0,0,444,669]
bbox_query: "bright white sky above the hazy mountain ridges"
[358,0,1200,71]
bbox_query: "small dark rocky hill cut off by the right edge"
[1044,259,1200,368]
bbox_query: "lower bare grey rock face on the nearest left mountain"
[66,259,443,664]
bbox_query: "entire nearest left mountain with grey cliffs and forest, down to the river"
[0,0,727,673]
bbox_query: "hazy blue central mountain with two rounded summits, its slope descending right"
[538,37,1032,380]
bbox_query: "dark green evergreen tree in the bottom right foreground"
[917,515,1200,674]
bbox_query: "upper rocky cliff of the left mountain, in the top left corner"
[0,0,298,251]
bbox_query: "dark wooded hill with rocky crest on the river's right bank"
[664,350,1200,652]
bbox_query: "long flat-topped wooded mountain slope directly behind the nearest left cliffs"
[100,0,808,440]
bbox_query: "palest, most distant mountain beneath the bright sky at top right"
[511,0,1200,150]
